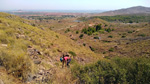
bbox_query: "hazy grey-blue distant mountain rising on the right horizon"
[98,6,150,16]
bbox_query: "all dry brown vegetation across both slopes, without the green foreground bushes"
[0,13,150,84]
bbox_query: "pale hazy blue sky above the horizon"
[0,0,150,10]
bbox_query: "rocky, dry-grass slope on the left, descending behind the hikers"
[0,13,101,84]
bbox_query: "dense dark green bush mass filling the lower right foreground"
[71,58,150,84]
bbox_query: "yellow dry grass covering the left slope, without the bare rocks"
[0,13,101,84]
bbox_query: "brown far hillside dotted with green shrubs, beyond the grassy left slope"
[58,18,150,57]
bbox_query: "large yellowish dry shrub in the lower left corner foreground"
[0,50,34,81]
